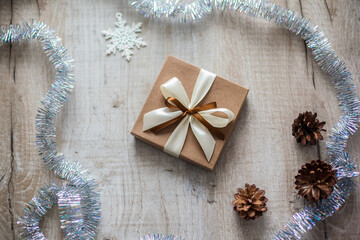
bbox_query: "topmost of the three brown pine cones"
[292,111,326,145]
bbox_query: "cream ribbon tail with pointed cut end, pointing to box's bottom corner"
[190,116,216,162]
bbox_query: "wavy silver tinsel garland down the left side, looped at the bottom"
[0,21,101,239]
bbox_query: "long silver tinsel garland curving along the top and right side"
[129,0,360,239]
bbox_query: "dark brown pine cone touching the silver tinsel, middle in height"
[295,160,336,202]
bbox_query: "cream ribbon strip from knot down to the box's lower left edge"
[164,116,190,157]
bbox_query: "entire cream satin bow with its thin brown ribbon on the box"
[143,69,234,162]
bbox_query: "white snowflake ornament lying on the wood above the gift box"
[102,13,146,61]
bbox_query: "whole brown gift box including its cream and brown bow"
[131,56,249,170]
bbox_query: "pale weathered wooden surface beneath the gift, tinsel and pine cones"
[0,0,360,240]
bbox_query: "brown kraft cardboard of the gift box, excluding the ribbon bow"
[131,56,249,170]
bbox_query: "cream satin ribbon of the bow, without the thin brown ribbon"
[143,69,234,162]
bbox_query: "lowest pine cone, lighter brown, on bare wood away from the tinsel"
[233,184,268,220]
